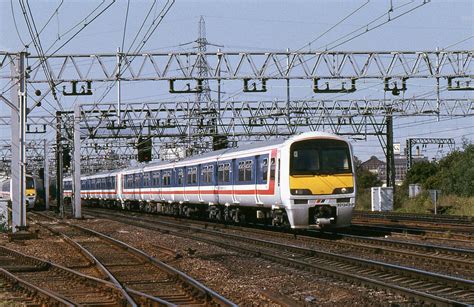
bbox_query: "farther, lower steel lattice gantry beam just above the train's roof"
[57,99,474,140]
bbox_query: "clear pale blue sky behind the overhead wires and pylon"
[0,0,474,159]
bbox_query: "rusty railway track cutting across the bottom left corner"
[0,246,139,306]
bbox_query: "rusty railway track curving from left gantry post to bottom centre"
[30,214,233,306]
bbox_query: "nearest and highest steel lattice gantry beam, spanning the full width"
[0,50,474,83]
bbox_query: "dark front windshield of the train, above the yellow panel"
[290,139,352,176]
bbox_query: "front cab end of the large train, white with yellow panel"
[281,137,355,228]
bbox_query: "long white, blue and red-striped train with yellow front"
[64,132,356,229]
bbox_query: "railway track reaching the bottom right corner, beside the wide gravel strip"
[87,210,474,305]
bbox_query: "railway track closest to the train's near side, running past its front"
[85,210,474,278]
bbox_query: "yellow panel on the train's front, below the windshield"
[290,174,354,195]
